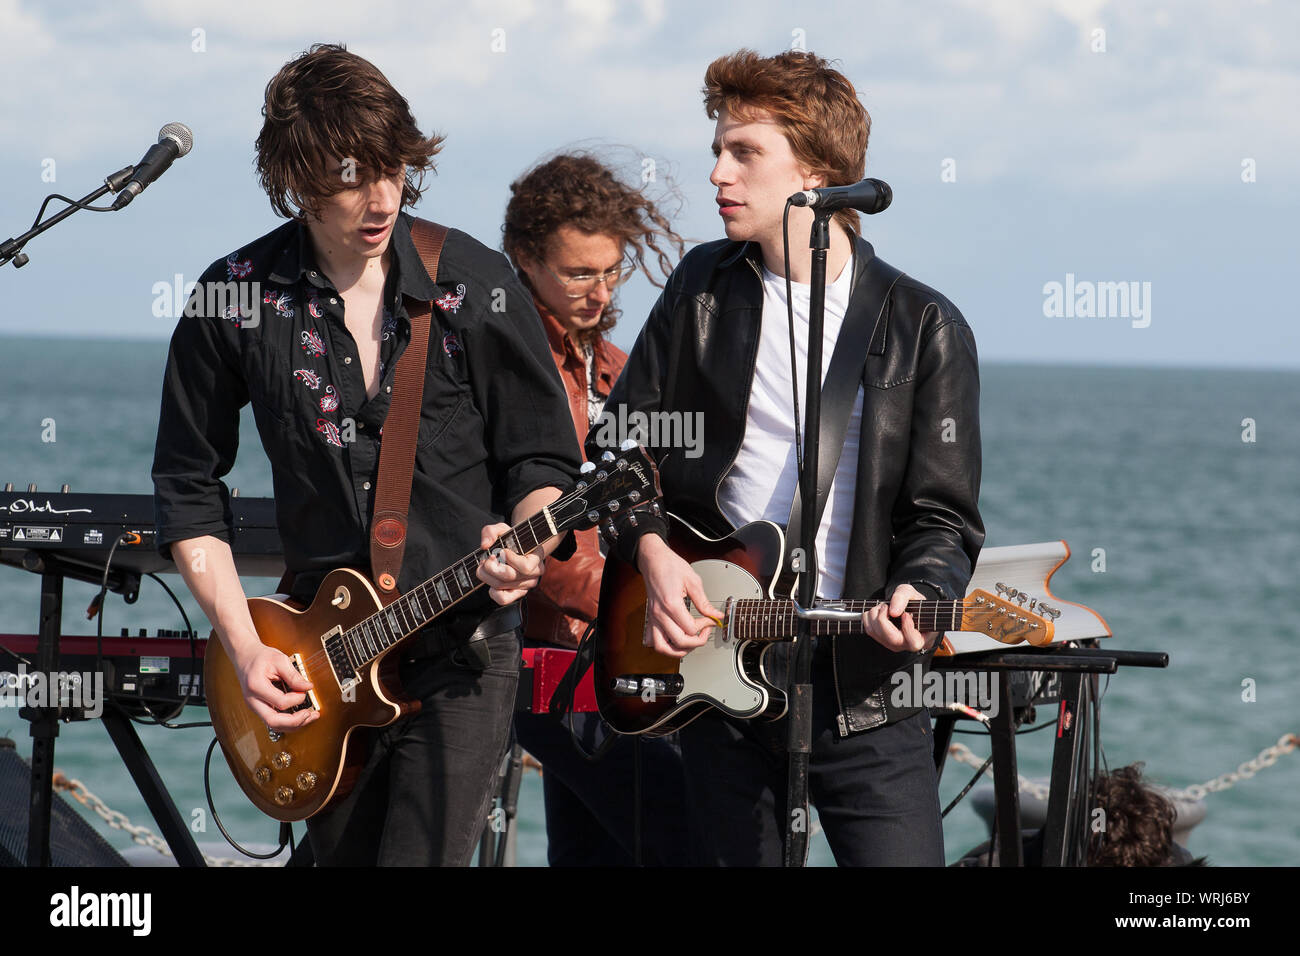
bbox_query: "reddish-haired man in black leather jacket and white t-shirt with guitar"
[588,51,984,866]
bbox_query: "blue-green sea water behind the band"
[0,338,1300,866]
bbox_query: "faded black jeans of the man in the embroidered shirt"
[307,632,520,866]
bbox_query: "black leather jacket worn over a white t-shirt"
[588,231,984,735]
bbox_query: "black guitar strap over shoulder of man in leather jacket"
[785,247,904,561]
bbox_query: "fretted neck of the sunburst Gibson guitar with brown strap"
[343,507,559,662]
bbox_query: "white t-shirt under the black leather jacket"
[718,260,862,600]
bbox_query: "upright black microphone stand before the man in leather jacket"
[784,208,835,866]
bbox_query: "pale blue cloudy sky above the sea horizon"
[0,0,1300,368]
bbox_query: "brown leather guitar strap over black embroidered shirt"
[371,219,447,605]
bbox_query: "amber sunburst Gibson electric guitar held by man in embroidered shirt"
[204,445,659,822]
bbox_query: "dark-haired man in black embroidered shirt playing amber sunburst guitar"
[153,46,579,865]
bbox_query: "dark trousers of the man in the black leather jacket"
[679,654,944,866]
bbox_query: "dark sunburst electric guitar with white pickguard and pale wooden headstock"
[594,515,1060,736]
